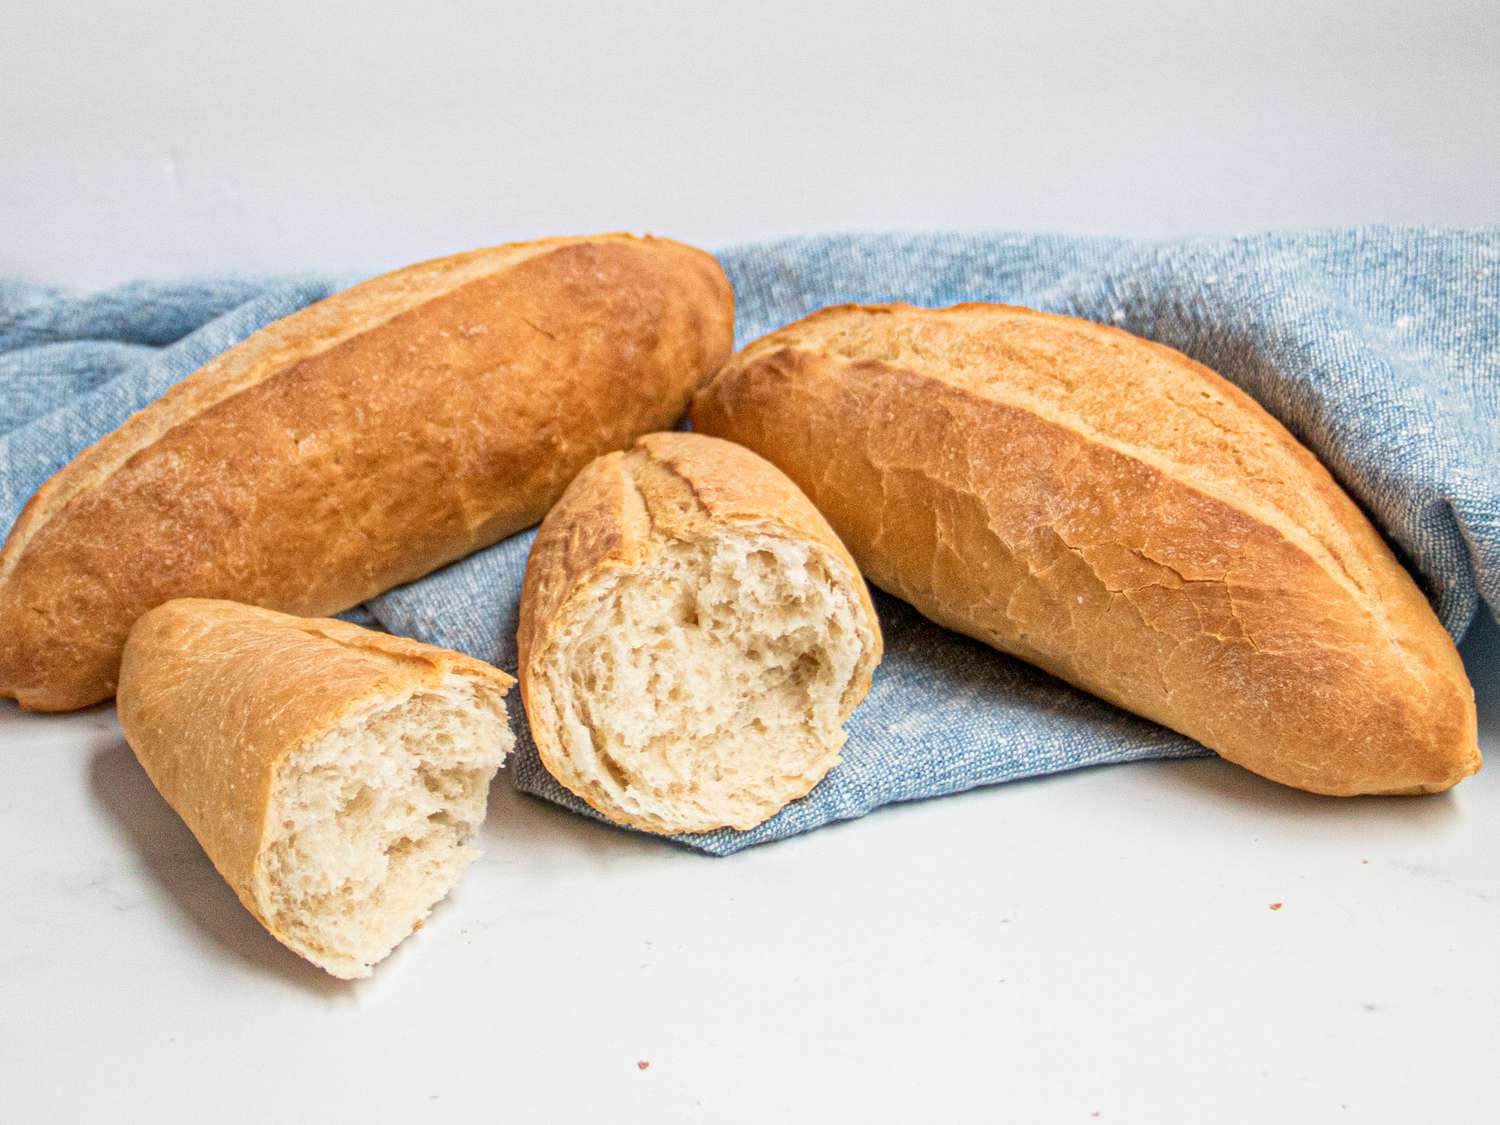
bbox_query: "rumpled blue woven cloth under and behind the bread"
[0,234,1500,855]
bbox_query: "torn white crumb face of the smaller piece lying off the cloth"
[255,675,513,980]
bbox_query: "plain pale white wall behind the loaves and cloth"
[0,0,1500,285]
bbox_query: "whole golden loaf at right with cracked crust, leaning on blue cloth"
[692,305,1479,795]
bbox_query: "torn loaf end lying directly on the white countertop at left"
[119,599,513,980]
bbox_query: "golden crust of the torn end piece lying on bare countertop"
[117,599,515,948]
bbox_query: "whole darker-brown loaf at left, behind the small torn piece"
[0,236,734,711]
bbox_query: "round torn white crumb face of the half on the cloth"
[531,528,879,833]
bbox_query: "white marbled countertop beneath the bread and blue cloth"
[0,624,1500,1125]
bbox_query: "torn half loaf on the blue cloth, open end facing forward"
[519,434,881,833]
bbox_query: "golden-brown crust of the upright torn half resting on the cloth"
[516,432,882,831]
